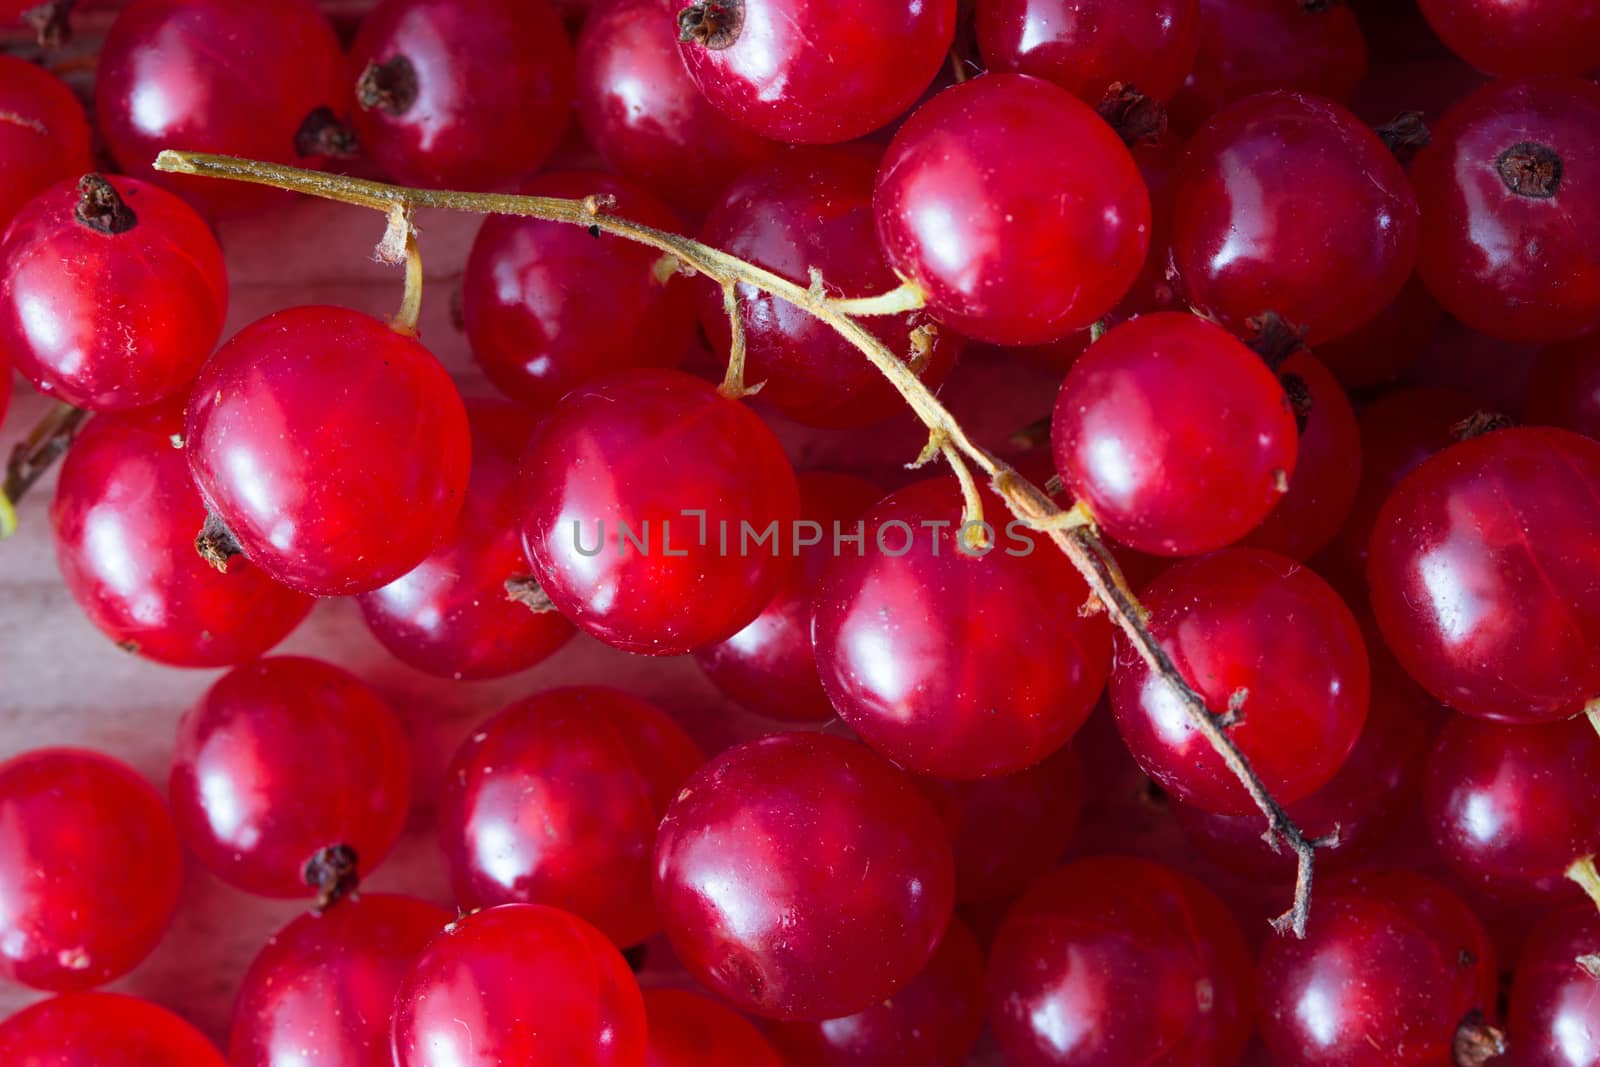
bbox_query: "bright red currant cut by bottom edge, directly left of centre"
[390,904,645,1067]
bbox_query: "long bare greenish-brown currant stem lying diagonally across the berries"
[155,150,1333,937]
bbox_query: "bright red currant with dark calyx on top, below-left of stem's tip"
[0,178,227,411]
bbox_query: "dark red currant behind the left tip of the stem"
[94,0,350,214]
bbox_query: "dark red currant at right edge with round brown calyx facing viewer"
[1411,78,1600,344]
